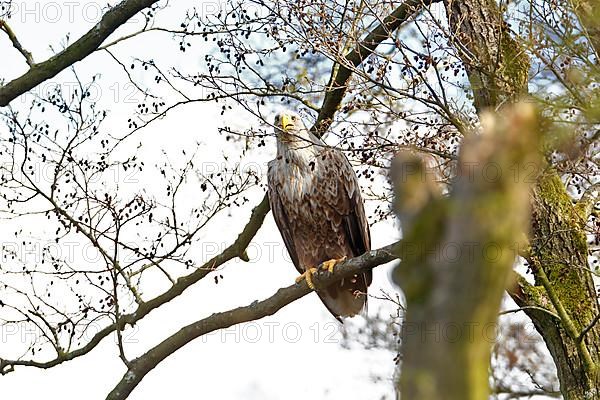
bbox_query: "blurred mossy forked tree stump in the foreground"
[392,104,538,400]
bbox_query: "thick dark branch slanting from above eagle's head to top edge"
[311,0,441,136]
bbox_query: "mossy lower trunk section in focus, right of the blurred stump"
[510,171,600,400]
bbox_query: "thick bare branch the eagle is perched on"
[106,243,397,400]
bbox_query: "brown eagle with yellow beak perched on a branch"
[267,111,372,321]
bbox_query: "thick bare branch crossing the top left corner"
[0,0,158,106]
